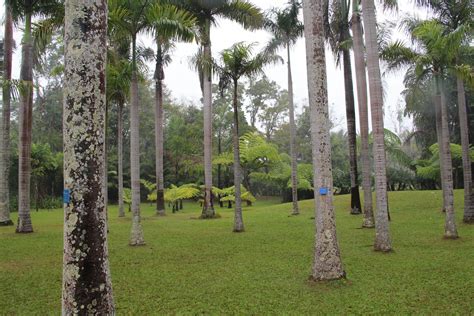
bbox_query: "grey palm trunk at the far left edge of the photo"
[0,4,13,226]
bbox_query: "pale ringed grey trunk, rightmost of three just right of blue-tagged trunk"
[362,0,392,252]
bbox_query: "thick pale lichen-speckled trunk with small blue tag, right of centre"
[303,0,345,281]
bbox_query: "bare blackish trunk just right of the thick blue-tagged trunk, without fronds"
[342,46,361,215]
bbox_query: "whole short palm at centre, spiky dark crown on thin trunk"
[215,43,281,232]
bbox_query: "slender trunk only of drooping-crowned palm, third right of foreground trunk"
[155,40,166,216]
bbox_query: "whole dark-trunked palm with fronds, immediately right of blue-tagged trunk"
[326,0,361,215]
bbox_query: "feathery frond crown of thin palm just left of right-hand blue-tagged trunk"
[263,0,304,52]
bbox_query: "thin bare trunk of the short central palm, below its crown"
[232,80,244,233]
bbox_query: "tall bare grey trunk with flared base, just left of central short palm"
[201,21,216,218]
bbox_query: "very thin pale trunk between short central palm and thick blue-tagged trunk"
[286,44,300,215]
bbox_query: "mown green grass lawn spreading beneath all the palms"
[0,191,474,315]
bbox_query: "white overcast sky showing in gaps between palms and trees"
[0,0,430,130]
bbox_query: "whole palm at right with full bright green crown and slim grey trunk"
[382,20,466,238]
